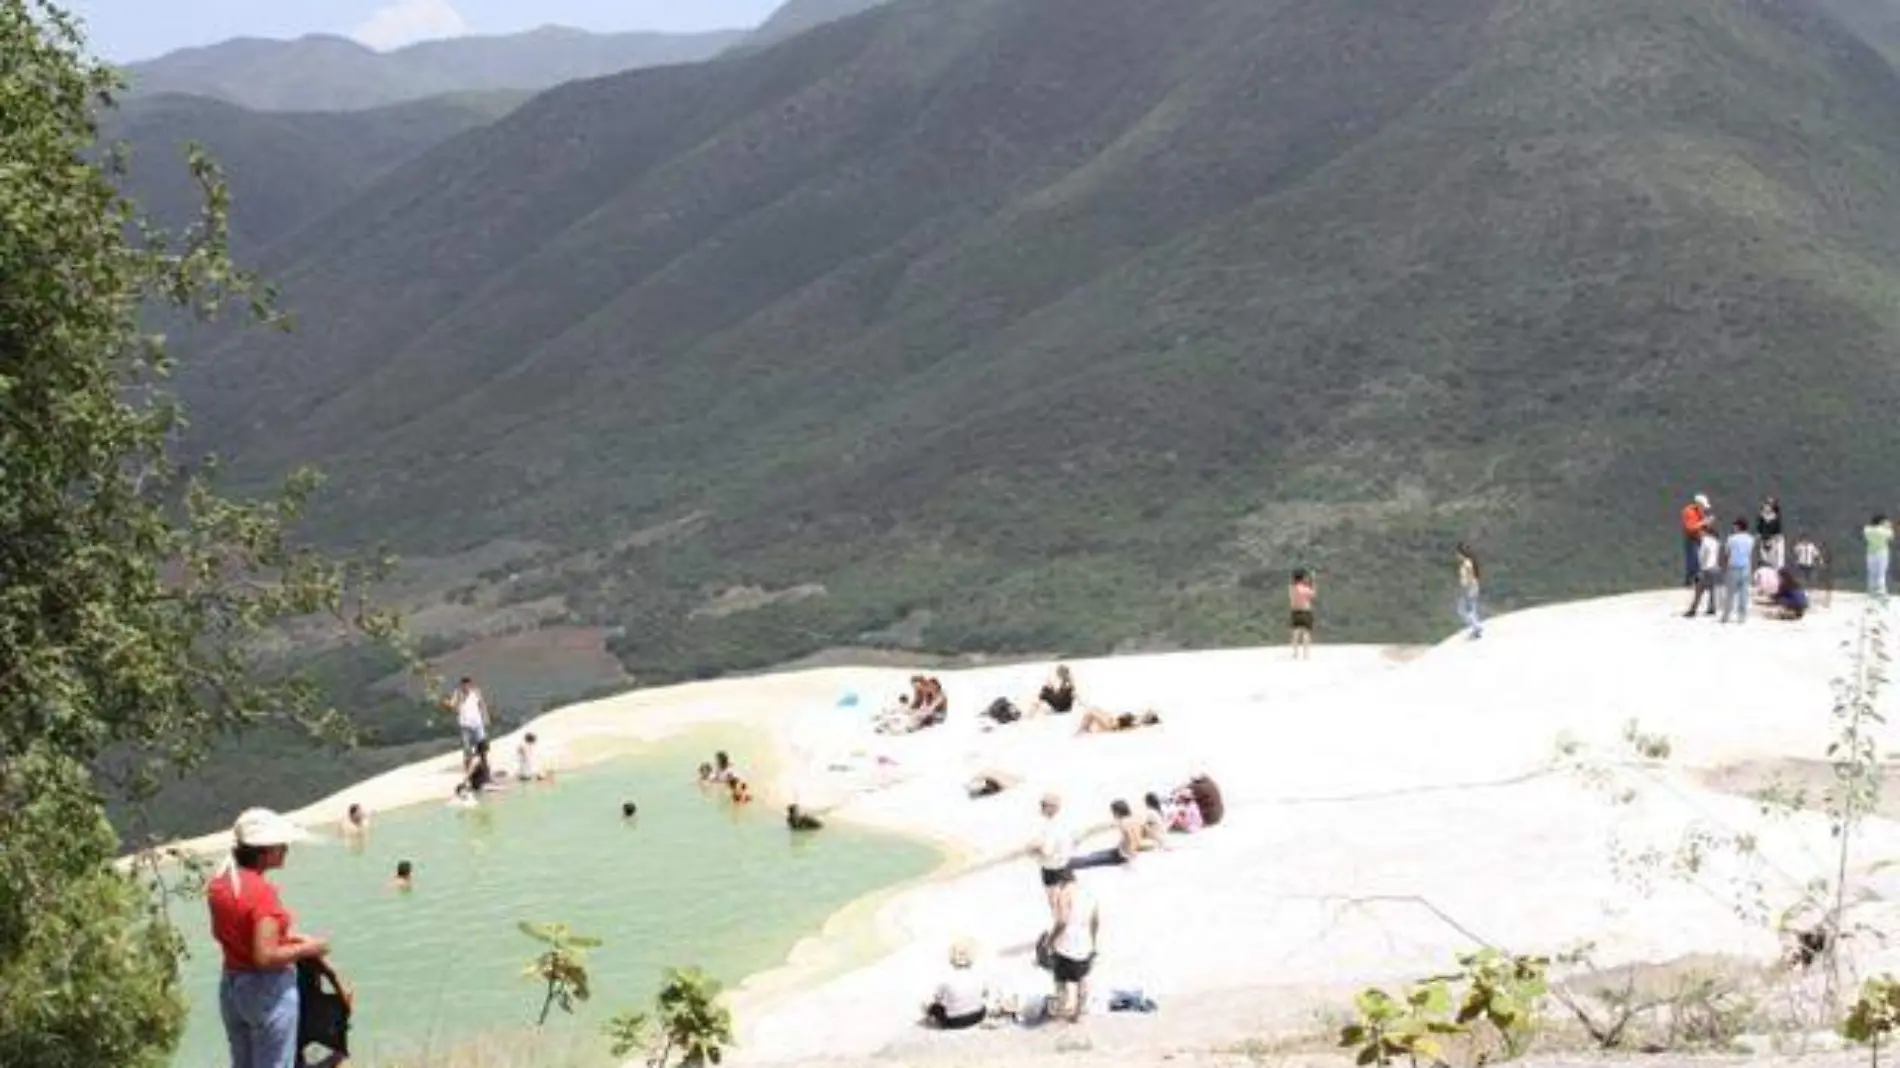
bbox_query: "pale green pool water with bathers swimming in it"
[173,734,939,1068]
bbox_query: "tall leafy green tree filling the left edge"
[0,0,395,1068]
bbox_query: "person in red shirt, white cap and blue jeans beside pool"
[205,808,331,1068]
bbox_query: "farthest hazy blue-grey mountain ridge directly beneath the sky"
[125,27,745,112]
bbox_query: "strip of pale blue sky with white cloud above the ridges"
[61,0,781,63]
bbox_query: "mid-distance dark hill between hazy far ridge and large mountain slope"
[101,93,523,257]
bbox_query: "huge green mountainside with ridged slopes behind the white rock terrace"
[182,0,1900,680]
